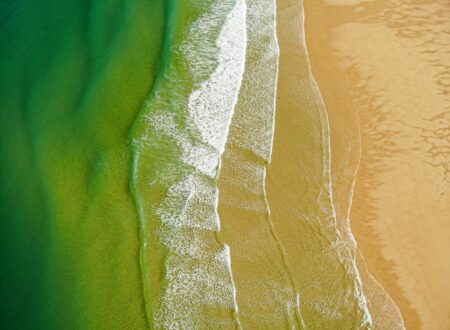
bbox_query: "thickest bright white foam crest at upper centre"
[186,0,246,160]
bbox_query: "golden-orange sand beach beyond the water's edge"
[305,0,450,329]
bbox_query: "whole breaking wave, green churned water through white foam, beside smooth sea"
[130,0,246,329]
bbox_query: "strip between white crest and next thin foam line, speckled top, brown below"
[218,0,294,329]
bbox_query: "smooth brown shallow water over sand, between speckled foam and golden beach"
[219,0,399,329]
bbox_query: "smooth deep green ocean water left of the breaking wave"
[0,0,171,329]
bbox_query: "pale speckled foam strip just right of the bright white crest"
[229,0,279,161]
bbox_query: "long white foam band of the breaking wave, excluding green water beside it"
[146,0,246,329]
